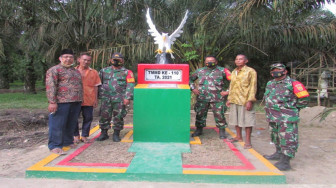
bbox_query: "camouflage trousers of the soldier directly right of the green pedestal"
[194,101,227,129]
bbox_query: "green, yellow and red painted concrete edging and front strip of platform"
[26,125,286,184]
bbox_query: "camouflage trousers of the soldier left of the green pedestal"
[99,99,127,130]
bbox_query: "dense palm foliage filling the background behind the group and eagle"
[0,0,336,98]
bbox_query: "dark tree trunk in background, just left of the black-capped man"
[24,56,36,94]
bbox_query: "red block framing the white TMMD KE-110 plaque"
[138,64,189,84]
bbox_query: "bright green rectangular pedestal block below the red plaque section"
[133,84,190,144]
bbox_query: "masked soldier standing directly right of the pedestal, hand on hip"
[189,56,231,139]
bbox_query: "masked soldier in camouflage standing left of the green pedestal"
[96,53,135,142]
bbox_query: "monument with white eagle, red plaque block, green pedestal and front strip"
[127,9,190,174]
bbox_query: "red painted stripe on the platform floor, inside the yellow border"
[57,127,255,170]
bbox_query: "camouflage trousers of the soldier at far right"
[269,122,299,158]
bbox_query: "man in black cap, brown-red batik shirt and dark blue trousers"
[46,49,83,155]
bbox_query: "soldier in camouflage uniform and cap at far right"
[264,63,309,170]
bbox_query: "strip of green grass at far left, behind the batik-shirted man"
[0,91,48,109]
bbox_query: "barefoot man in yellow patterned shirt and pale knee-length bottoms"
[226,54,257,149]
